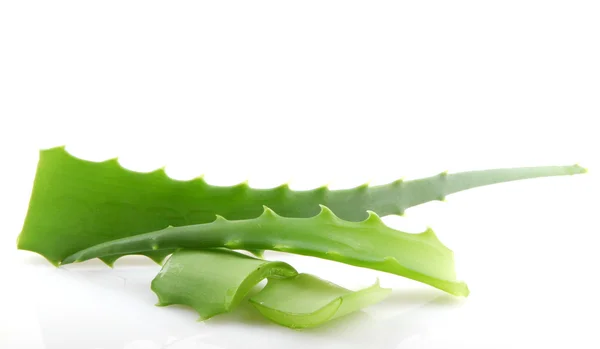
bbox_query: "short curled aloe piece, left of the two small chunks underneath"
[151,249,298,320]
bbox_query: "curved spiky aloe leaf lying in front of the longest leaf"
[62,205,469,296]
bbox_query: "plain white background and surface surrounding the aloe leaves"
[0,0,600,349]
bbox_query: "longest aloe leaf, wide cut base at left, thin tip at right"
[17,147,585,265]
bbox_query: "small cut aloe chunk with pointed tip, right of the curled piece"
[250,274,391,328]
